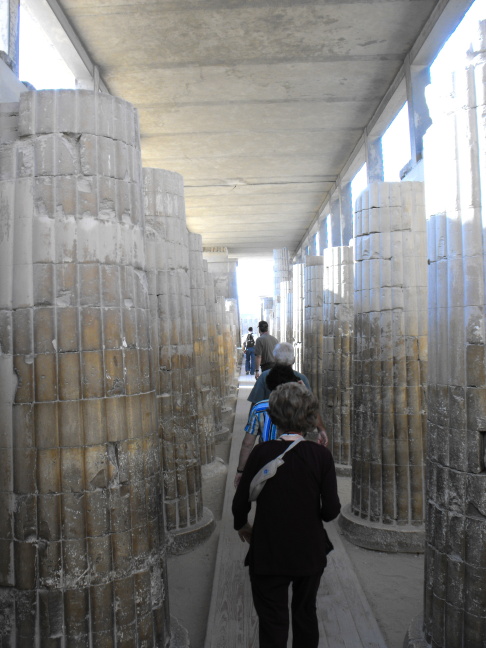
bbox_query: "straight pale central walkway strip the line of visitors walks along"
[205,372,387,648]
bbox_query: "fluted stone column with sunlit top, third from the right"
[321,246,354,475]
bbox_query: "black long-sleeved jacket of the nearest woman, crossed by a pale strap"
[233,441,341,576]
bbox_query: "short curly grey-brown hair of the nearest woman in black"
[268,383,319,436]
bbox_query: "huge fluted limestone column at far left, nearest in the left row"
[0,91,170,646]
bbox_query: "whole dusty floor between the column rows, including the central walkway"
[169,371,423,648]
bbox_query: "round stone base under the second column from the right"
[339,504,425,553]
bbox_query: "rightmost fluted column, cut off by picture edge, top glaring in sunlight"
[414,21,486,648]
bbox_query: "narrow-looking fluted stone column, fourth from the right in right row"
[303,256,324,398]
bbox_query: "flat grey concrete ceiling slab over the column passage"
[60,0,438,257]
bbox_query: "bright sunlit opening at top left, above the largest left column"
[19,0,76,90]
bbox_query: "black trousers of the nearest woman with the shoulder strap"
[250,569,324,648]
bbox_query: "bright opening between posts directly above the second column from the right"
[381,103,412,182]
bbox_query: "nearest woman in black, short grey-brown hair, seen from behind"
[233,383,341,648]
